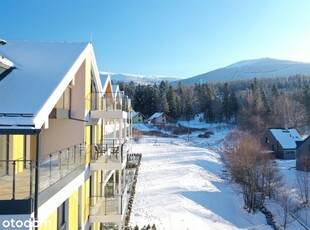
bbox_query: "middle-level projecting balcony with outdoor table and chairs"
[90,138,129,170]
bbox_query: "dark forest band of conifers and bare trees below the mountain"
[119,75,310,134]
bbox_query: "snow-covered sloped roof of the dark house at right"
[270,128,303,149]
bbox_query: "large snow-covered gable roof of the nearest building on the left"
[0,41,101,129]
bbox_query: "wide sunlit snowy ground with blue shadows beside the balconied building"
[130,135,271,230]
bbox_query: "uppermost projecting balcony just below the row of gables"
[87,92,131,119]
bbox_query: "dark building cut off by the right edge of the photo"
[296,136,310,172]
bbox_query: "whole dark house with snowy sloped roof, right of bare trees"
[261,128,303,160]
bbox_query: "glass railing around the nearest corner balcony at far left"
[0,143,85,200]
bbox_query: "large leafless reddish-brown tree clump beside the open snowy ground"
[224,131,281,212]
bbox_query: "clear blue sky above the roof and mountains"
[0,0,310,78]
